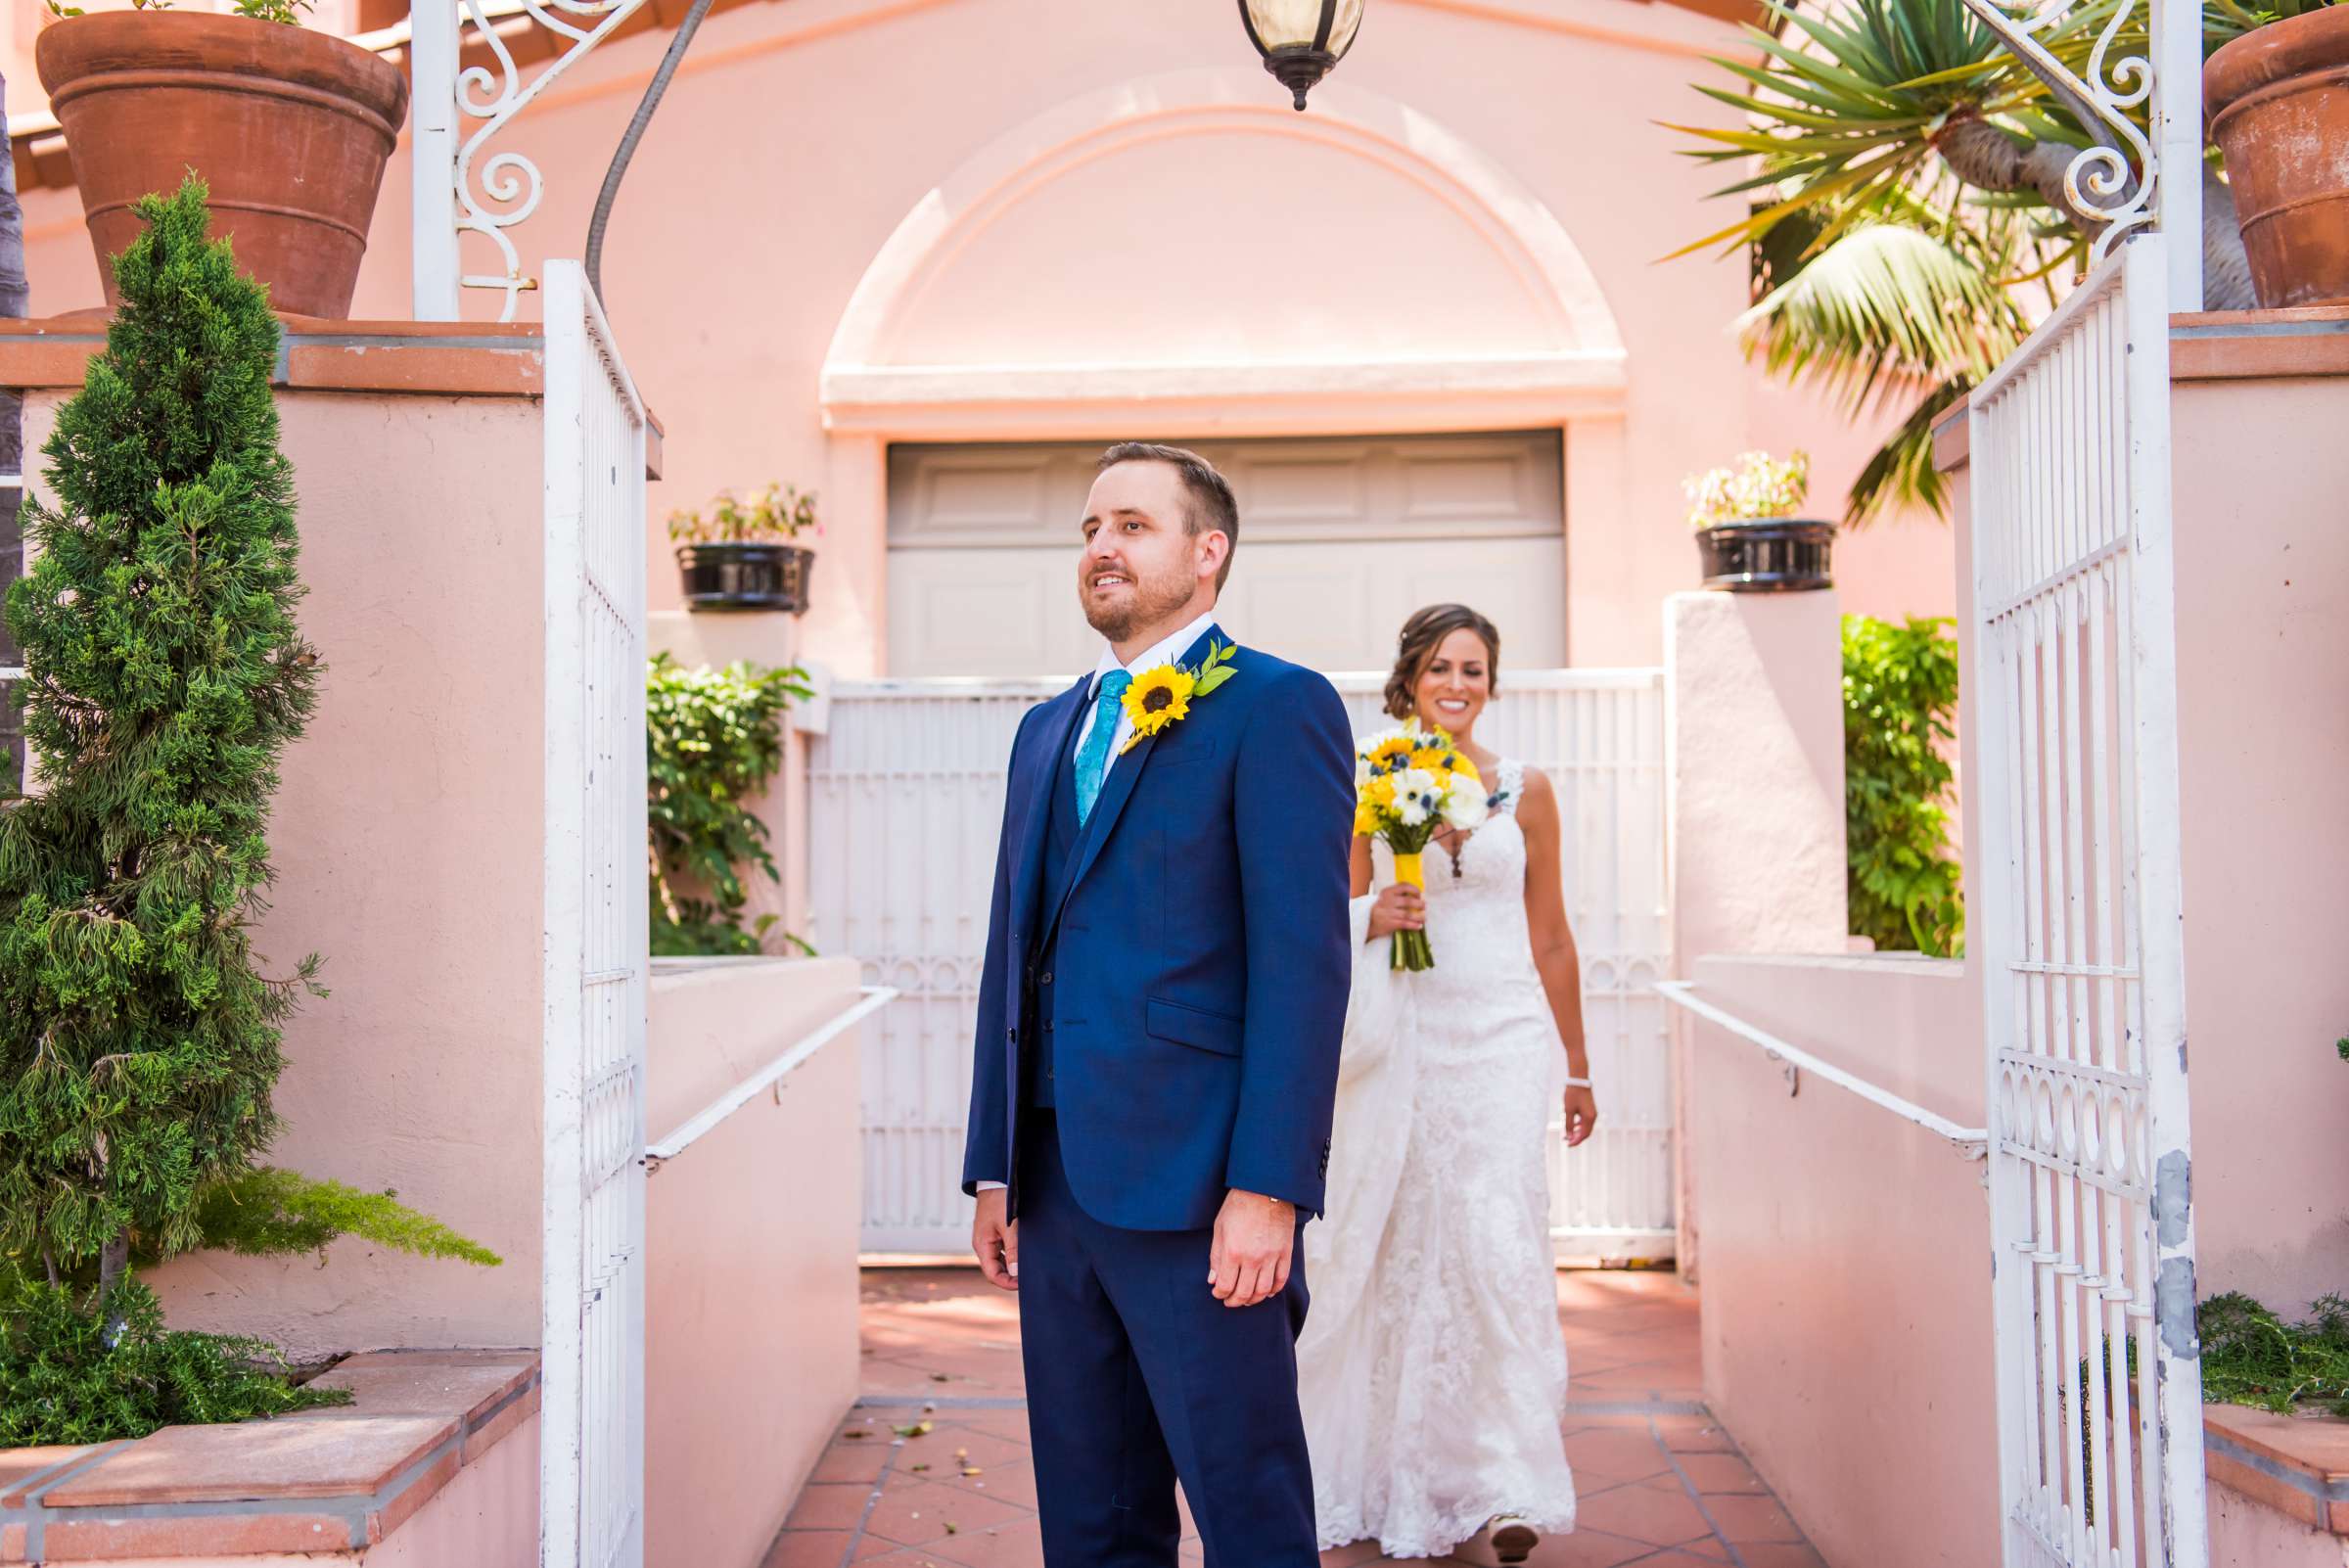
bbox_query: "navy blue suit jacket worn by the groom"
[963,629,1353,1230]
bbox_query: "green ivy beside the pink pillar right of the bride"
[1844,615,1966,957]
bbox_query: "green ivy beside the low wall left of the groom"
[644,653,812,957]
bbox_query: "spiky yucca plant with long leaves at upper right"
[1675,0,2292,524]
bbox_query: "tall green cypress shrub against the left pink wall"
[0,176,317,1301]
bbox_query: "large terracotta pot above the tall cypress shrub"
[33,12,409,317]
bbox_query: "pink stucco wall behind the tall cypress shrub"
[25,390,545,1355]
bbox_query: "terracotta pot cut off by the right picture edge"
[2203,5,2349,310]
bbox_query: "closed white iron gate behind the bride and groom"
[808,669,1673,1258]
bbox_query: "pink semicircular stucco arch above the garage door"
[822,70,1626,438]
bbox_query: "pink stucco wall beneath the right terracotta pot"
[2171,376,2349,1314]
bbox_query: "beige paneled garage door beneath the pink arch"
[888,430,1567,676]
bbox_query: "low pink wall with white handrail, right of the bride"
[1681,955,1999,1568]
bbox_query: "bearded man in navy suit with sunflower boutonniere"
[963,441,1353,1568]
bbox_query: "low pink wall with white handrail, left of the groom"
[644,957,862,1566]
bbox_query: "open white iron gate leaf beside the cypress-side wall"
[538,260,648,1568]
